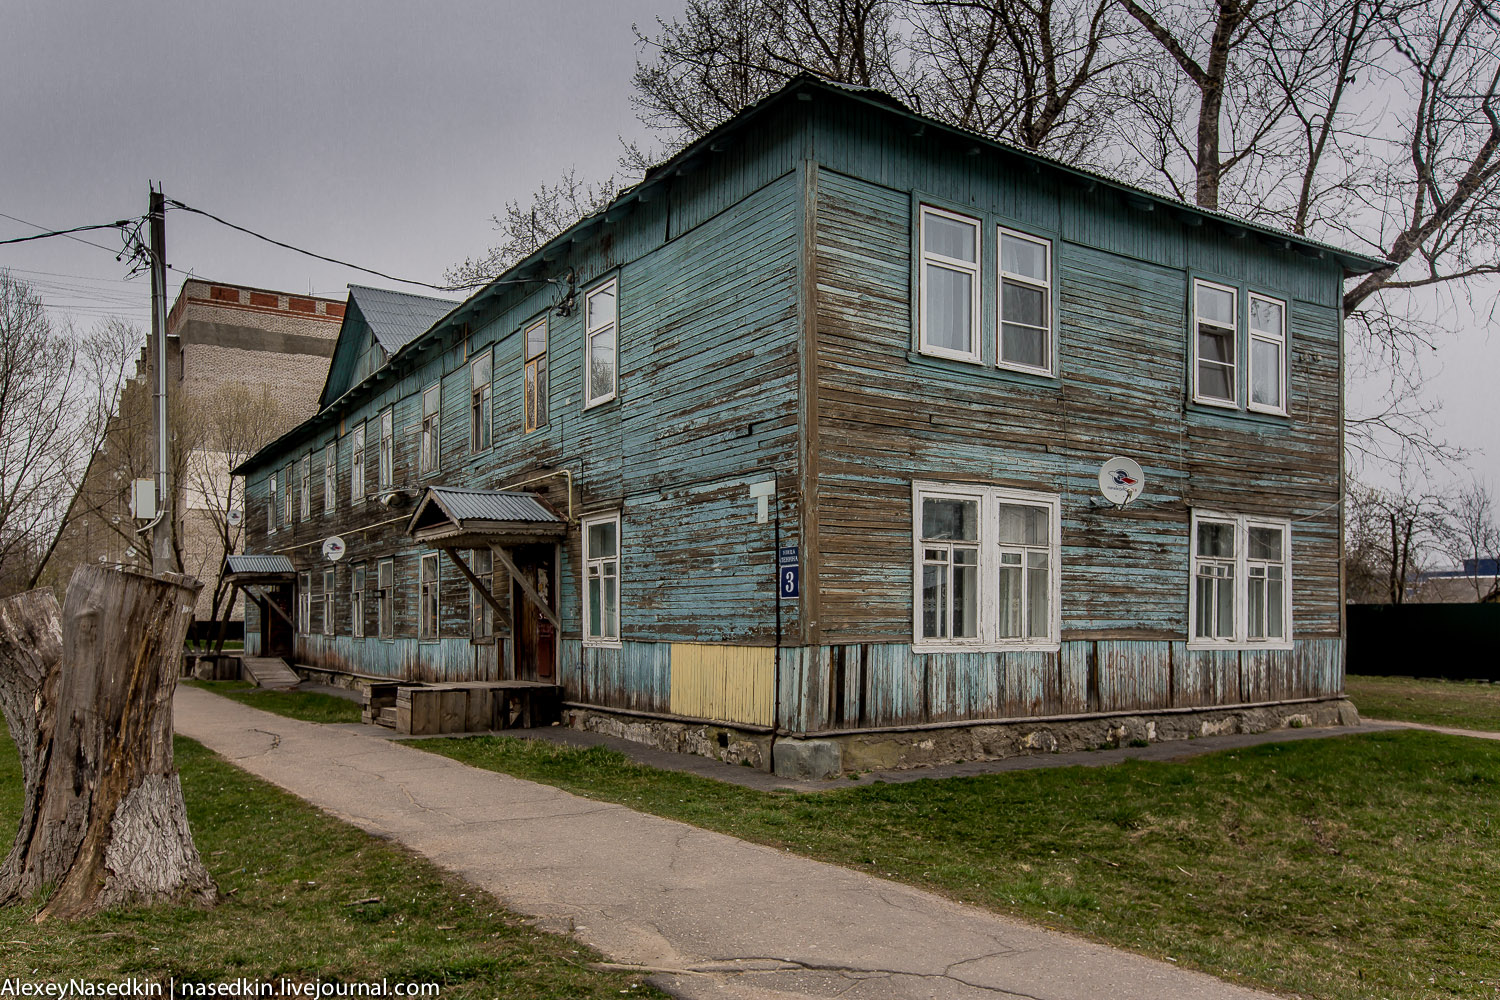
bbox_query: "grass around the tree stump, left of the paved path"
[0,726,663,1000]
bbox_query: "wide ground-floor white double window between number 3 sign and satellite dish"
[912,483,1062,649]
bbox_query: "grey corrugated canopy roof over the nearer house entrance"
[407,486,567,549]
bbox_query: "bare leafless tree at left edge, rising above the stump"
[0,271,135,594]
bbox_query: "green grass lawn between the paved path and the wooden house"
[414,732,1500,1000]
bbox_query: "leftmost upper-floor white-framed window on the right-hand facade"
[917,205,980,361]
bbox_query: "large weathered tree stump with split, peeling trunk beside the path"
[0,567,218,921]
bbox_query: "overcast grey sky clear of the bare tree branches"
[0,0,1500,500]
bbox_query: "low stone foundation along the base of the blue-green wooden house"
[563,699,1359,780]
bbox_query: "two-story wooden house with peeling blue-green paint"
[231,78,1380,772]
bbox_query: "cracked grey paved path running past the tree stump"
[176,687,1272,1000]
